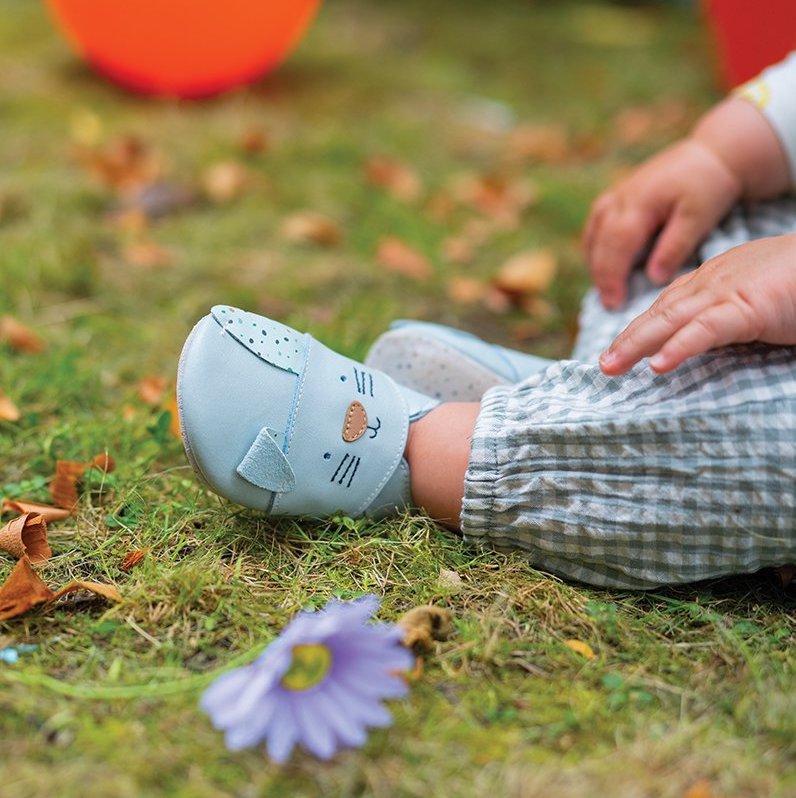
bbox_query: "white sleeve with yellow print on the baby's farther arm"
[736,51,796,187]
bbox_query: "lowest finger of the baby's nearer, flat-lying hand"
[650,302,755,374]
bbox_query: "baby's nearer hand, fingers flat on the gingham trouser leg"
[600,234,796,375]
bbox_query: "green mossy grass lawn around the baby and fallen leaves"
[0,0,796,798]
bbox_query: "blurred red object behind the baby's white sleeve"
[705,0,796,87]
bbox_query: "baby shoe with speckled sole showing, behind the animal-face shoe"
[365,320,553,402]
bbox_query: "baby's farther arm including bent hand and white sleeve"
[584,54,796,307]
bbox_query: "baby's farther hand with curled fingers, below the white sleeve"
[584,139,743,308]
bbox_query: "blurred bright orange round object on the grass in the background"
[48,0,320,97]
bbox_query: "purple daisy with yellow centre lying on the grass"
[201,595,414,762]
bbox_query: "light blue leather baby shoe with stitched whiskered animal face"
[177,305,438,518]
